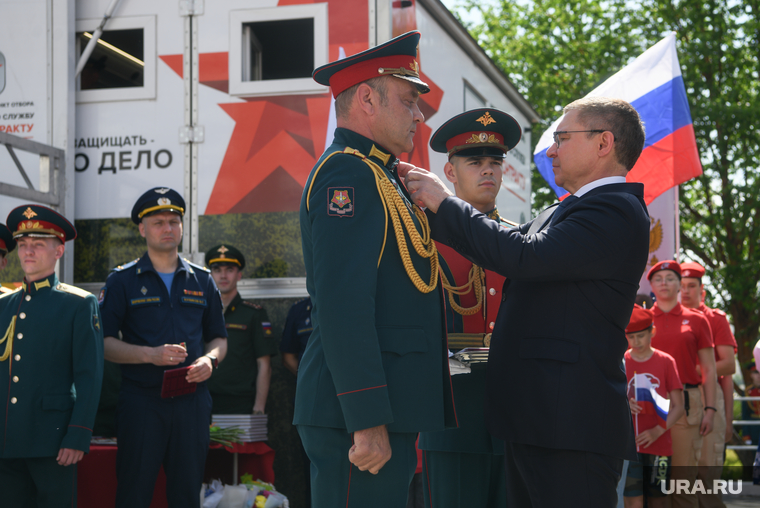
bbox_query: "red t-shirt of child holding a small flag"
[625,349,683,457]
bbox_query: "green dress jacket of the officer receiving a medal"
[294,128,455,432]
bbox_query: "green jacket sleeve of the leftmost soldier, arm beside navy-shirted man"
[61,295,103,452]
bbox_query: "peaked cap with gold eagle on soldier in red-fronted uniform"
[430,108,522,157]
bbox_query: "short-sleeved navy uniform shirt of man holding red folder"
[99,253,227,390]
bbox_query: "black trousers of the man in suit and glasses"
[504,443,623,508]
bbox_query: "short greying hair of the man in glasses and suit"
[565,97,646,171]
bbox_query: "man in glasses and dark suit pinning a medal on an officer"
[401,97,649,508]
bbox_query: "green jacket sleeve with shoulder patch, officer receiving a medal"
[309,155,398,432]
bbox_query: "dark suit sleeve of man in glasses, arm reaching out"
[431,192,641,281]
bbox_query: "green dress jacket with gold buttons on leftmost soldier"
[0,274,103,458]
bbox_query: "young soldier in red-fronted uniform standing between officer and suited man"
[419,108,521,508]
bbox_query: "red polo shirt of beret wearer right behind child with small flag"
[652,303,713,385]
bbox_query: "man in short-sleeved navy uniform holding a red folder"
[100,187,227,508]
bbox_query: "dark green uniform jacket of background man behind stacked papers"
[208,293,277,414]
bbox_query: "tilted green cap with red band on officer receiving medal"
[312,31,430,97]
